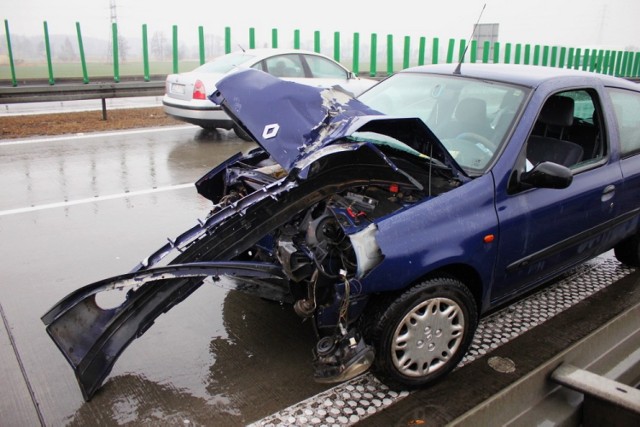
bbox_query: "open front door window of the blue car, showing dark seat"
[527,89,607,169]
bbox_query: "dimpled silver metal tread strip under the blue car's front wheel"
[248,256,635,427]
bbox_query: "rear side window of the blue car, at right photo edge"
[609,88,640,156]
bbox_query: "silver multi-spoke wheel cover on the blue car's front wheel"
[391,298,465,377]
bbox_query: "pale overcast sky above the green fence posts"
[0,0,640,49]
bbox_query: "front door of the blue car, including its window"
[491,89,622,304]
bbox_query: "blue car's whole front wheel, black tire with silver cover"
[363,277,478,388]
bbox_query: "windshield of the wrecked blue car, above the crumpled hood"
[358,73,526,173]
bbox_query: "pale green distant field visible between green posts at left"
[0,61,200,81]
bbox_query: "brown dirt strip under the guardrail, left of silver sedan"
[0,107,183,139]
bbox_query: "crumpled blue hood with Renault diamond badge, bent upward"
[209,69,466,176]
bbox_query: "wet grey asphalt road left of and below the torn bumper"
[0,126,336,426]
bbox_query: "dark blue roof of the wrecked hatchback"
[401,63,640,90]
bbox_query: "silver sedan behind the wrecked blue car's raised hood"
[162,49,377,139]
